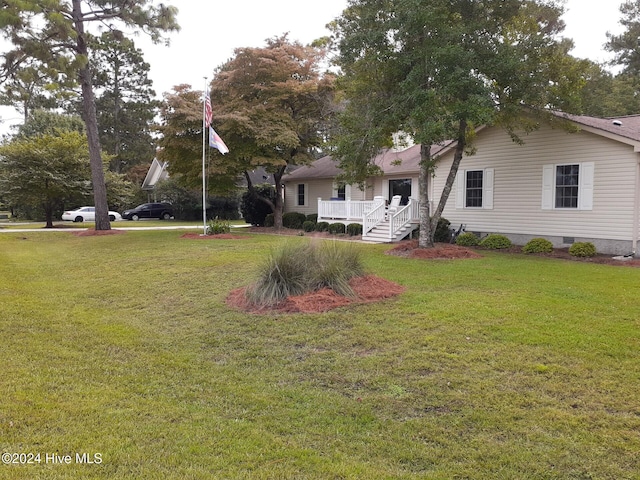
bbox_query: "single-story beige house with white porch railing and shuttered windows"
[284,114,640,255]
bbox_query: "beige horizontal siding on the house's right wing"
[433,126,640,240]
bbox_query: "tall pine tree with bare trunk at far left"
[0,0,178,230]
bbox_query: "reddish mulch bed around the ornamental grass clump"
[226,275,405,314]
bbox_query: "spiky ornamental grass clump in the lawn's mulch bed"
[246,242,364,307]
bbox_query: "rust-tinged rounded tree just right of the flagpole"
[211,35,335,228]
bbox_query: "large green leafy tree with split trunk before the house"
[333,0,581,247]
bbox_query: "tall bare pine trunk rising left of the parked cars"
[73,0,111,230]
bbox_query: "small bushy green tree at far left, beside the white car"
[0,131,91,228]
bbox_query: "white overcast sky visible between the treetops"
[0,0,622,134]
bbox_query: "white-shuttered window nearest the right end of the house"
[542,162,594,210]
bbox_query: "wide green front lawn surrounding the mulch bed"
[0,231,640,480]
